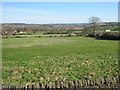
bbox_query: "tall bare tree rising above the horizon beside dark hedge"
[89,16,100,35]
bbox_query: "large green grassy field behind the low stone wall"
[2,37,119,85]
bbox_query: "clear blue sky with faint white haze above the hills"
[2,2,118,24]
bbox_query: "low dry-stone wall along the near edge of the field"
[2,76,120,90]
